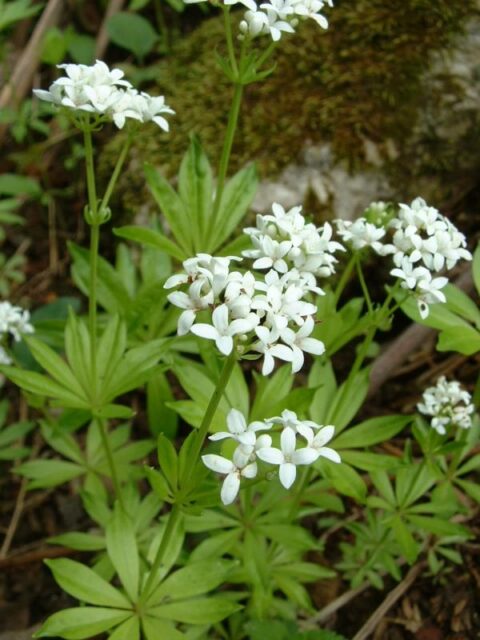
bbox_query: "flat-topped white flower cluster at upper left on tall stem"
[33,60,175,131]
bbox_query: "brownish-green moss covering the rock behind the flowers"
[104,0,476,212]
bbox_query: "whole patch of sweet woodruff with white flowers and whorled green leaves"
[0,0,480,640]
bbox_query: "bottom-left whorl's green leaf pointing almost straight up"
[106,504,140,602]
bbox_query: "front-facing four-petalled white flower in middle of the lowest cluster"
[257,428,318,489]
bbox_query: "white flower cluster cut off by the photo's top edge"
[185,0,333,42]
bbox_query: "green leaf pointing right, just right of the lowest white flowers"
[333,415,412,449]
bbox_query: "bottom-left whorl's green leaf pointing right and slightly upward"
[148,559,234,606]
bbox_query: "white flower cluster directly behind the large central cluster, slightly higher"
[243,202,345,278]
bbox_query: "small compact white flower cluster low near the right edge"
[417,376,475,435]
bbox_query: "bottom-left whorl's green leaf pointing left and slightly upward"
[45,558,131,609]
